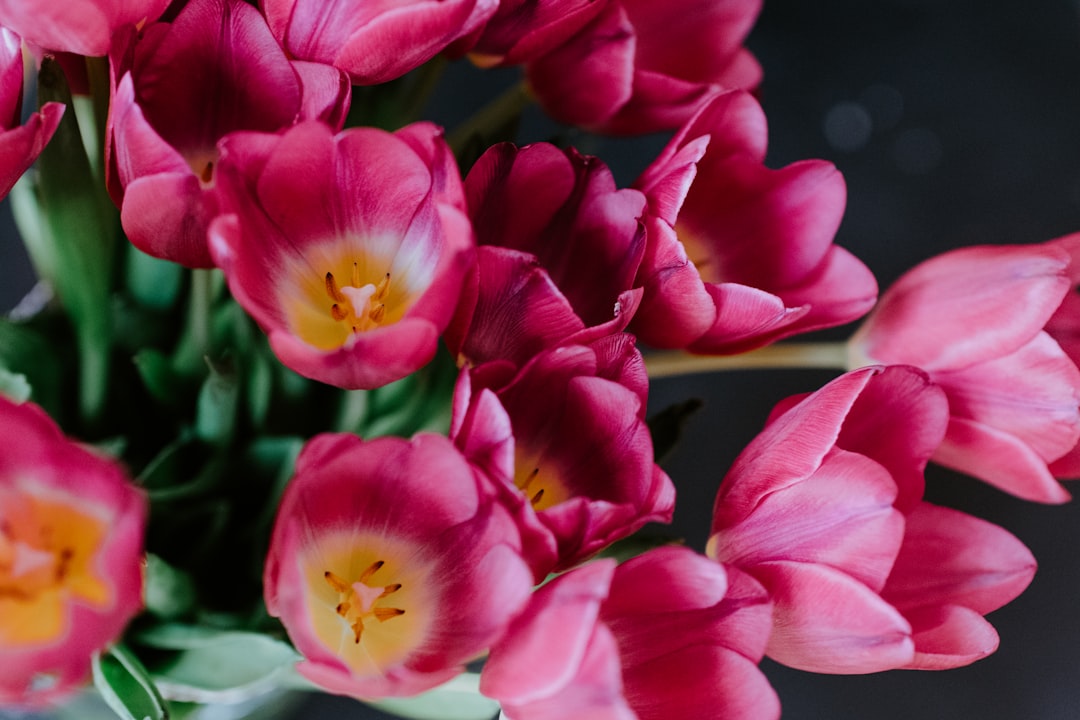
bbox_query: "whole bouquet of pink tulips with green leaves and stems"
[0,0,1080,720]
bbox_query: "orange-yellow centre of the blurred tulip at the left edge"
[0,492,112,647]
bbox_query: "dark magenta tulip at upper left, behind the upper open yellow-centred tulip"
[107,0,349,267]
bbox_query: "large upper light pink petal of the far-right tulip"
[852,245,1070,371]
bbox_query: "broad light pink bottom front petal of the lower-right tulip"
[752,562,915,675]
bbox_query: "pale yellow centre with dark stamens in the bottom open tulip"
[301,533,433,676]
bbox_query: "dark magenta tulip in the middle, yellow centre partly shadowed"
[451,335,675,579]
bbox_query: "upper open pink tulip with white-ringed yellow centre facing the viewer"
[210,122,474,389]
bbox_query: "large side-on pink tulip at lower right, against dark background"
[708,366,1035,674]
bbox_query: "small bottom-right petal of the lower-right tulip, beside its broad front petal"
[904,606,998,670]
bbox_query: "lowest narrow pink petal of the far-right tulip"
[933,418,1070,503]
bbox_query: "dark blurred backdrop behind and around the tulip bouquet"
[6,0,1080,720]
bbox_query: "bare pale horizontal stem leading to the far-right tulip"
[645,342,848,380]
